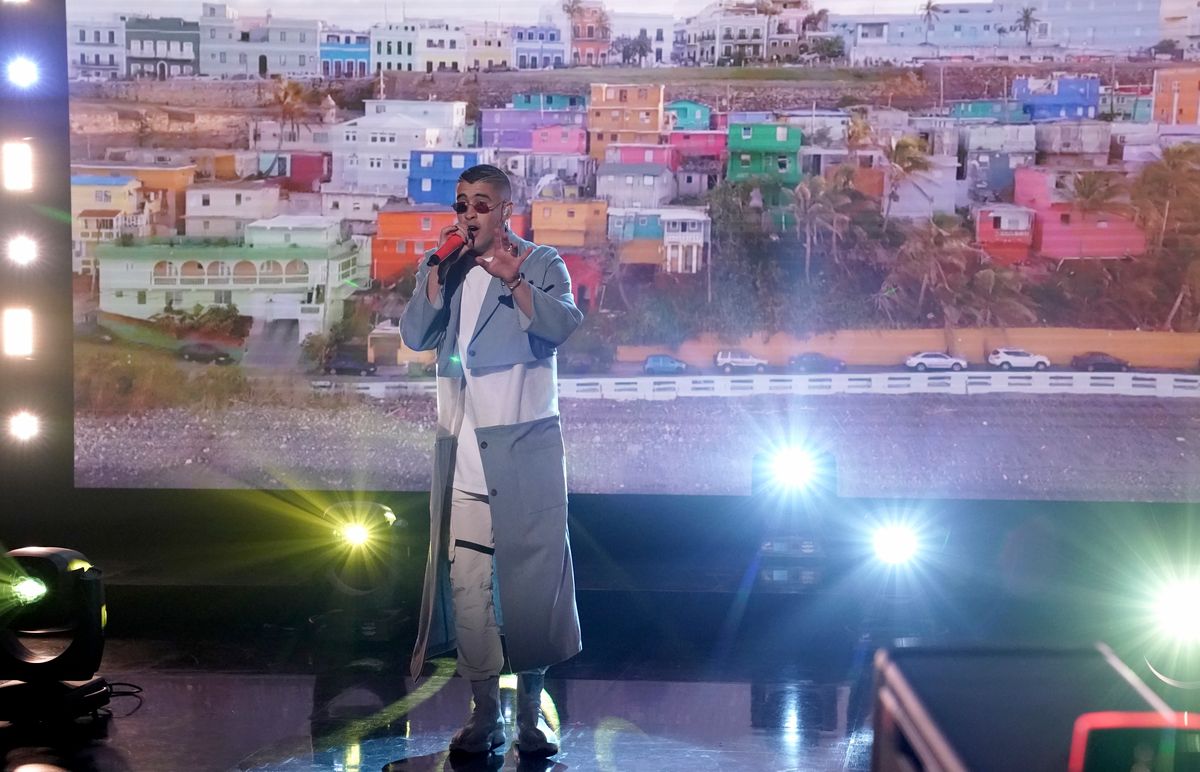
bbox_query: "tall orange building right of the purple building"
[588,83,671,161]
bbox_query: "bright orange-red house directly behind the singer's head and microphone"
[371,204,529,283]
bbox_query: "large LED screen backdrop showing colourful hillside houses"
[65,0,1200,501]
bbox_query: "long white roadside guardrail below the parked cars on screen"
[311,371,1200,400]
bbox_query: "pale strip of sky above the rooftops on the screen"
[67,0,984,28]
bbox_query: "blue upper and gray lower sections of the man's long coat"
[401,237,583,678]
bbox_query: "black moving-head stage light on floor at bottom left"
[0,546,109,722]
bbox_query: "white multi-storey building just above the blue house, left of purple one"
[322,100,468,202]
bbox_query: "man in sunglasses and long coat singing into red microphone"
[401,159,583,755]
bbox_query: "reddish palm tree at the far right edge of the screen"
[1133,143,1200,250]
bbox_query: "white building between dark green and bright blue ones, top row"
[200,2,320,78]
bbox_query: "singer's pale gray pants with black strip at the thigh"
[449,489,504,681]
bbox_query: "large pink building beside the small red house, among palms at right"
[1013,167,1146,261]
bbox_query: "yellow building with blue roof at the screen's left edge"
[71,174,158,274]
